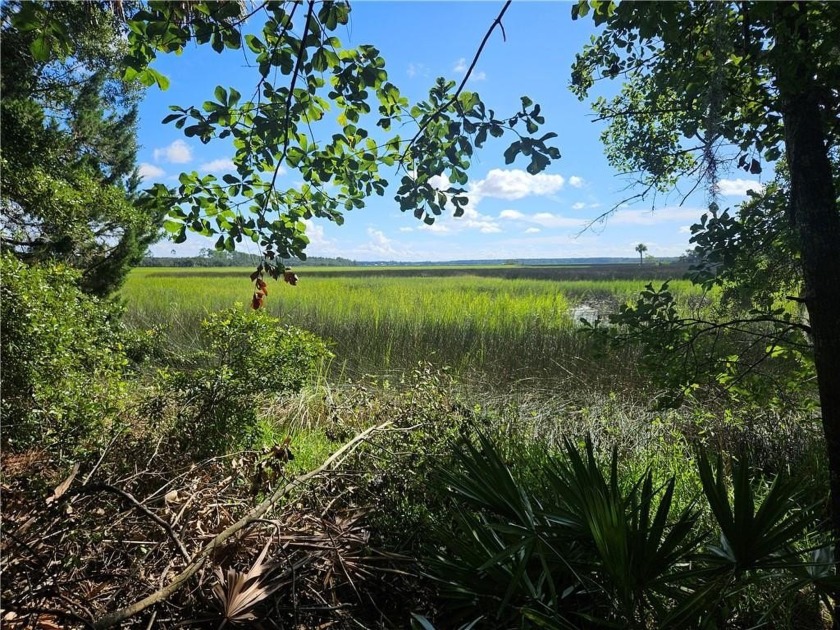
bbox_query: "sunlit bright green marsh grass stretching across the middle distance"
[122,268,700,387]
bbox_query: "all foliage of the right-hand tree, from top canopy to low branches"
[572,0,840,424]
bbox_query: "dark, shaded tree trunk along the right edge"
[777,11,840,628]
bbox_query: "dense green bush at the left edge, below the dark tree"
[0,254,128,453]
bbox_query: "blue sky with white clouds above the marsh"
[138,0,759,261]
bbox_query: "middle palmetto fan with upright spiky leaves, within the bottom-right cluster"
[548,442,702,627]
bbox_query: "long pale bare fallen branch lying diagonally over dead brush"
[93,421,391,630]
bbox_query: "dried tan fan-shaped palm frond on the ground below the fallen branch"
[213,540,282,626]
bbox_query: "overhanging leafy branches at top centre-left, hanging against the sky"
[106,2,560,268]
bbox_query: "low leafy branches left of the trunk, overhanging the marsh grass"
[586,282,814,408]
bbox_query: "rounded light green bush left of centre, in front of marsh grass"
[164,306,331,457]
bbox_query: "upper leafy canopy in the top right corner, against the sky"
[572,0,840,191]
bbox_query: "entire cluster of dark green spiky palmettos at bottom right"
[427,436,834,628]
